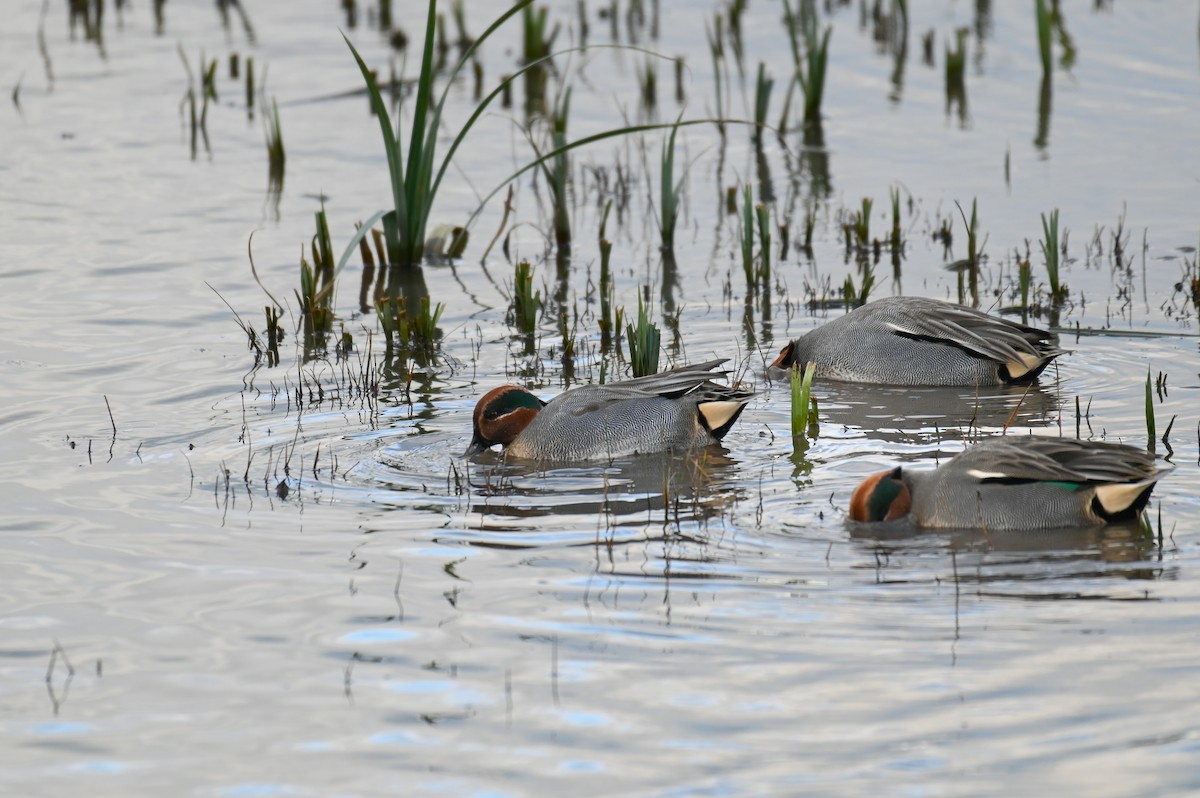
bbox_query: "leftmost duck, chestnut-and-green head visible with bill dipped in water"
[463,358,754,462]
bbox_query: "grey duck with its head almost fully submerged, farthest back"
[767,296,1063,386]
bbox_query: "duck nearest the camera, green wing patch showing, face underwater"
[850,436,1171,530]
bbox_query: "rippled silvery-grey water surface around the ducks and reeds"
[0,1,1200,797]
